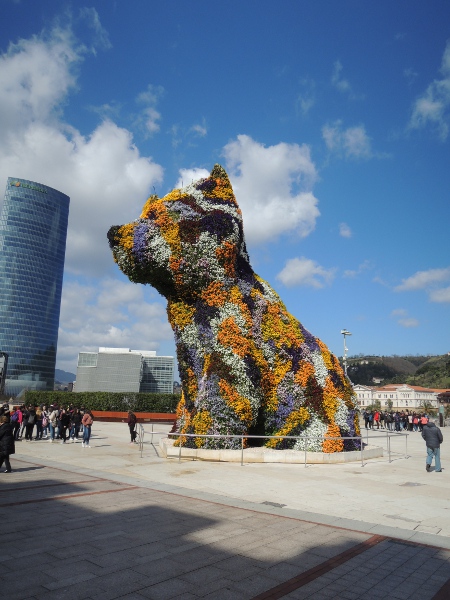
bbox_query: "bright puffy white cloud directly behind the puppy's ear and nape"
[224,135,320,243]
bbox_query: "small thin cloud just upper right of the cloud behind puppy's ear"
[322,121,374,159]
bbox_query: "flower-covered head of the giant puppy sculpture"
[108,165,253,298]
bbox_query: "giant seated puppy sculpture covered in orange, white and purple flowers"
[108,165,359,452]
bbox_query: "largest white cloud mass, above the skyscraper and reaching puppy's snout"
[0,20,162,275]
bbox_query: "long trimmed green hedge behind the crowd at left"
[25,391,180,413]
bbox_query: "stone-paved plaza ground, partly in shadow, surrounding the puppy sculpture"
[0,422,450,600]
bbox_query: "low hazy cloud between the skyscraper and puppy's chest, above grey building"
[58,278,173,371]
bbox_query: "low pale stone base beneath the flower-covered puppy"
[159,438,383,465]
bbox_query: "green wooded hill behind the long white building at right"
[347,354,450,389]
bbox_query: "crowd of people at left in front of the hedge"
[0,404,94,473]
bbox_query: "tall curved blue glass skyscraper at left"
[0,177,70,395]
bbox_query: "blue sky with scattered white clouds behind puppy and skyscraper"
[0,0,450,372]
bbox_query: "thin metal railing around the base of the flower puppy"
[134,423,409,467]
